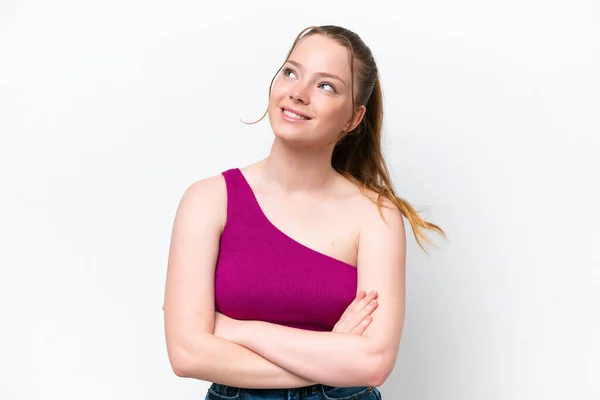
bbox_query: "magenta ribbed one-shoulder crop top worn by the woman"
[215,168,357,331]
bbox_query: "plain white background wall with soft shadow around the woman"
[0,0,600,400]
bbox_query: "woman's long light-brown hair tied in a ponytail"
[244,25,446,253]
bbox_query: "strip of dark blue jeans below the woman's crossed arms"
[205,383,382,400]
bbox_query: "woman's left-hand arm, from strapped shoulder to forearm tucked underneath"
[164,175,316,388]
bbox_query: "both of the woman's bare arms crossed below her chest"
[164,177,406,388]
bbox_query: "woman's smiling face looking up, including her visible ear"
[269,35,365,145]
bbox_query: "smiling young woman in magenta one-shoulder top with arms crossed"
[164,26,444,400]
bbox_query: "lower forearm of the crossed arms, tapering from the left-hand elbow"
[178,333,316,389]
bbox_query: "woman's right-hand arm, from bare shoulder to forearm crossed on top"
[215,202,406,386]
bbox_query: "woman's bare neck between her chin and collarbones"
[262,138,337,191]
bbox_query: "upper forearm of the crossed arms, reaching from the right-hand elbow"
[228,321,382,386]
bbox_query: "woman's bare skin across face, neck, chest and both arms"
[164,35,406,388]
